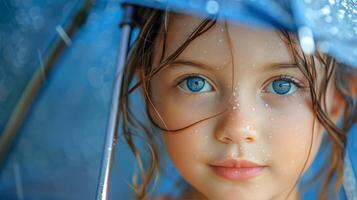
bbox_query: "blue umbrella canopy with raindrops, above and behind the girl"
[0,0,357,199]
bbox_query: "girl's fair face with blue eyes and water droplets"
[149,15,338,199]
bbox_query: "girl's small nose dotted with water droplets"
[215,100,259,144]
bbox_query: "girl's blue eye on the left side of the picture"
[178,76,213,93]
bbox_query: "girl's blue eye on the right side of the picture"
[267,78,298,95]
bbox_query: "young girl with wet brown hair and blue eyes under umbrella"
[120,9,357,199]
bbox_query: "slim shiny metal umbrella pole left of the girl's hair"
[97,3,134,200]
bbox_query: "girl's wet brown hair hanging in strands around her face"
[119,8,357,199]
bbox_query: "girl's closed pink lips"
[209,159,266,181]
